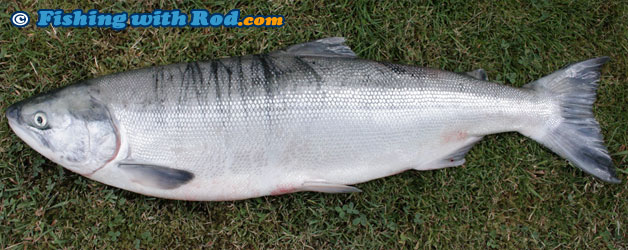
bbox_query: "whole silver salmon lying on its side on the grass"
[6,37,620,200]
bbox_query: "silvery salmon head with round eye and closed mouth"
[6,84,120,175]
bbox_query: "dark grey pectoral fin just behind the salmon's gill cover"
[118,164,194,189]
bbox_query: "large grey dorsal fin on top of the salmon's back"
[273,37,357,58]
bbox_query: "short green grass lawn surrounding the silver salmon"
[0,0,628,249]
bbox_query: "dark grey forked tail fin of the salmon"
[524,57,621,183]
